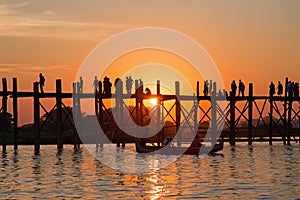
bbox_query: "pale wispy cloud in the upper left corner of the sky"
[0,2,129,40]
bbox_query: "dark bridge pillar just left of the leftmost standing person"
[33,82,40,154]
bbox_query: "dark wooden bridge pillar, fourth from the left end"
[56,79,63,149]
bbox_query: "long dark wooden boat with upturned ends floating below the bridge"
[135,139,224,155]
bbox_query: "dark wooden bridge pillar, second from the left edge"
[13,78,18,151]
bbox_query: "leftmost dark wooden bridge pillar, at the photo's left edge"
[2,78,9,152]
